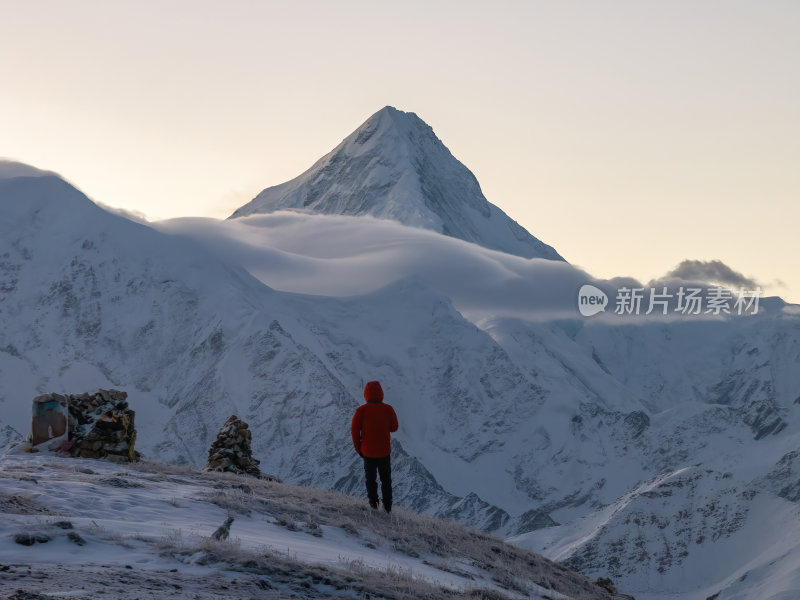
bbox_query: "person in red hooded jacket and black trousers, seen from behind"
[350,381,398,512]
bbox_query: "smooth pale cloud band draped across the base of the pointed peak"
[156,212,593,319]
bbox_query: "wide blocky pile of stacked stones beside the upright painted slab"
[67,390,140,463]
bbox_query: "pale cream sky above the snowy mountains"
[0,0,800,302]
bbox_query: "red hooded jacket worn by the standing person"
[350,381,398,458]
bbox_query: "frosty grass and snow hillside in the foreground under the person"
[0,454,607,600]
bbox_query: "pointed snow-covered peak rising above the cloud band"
[231,106,563,260]
